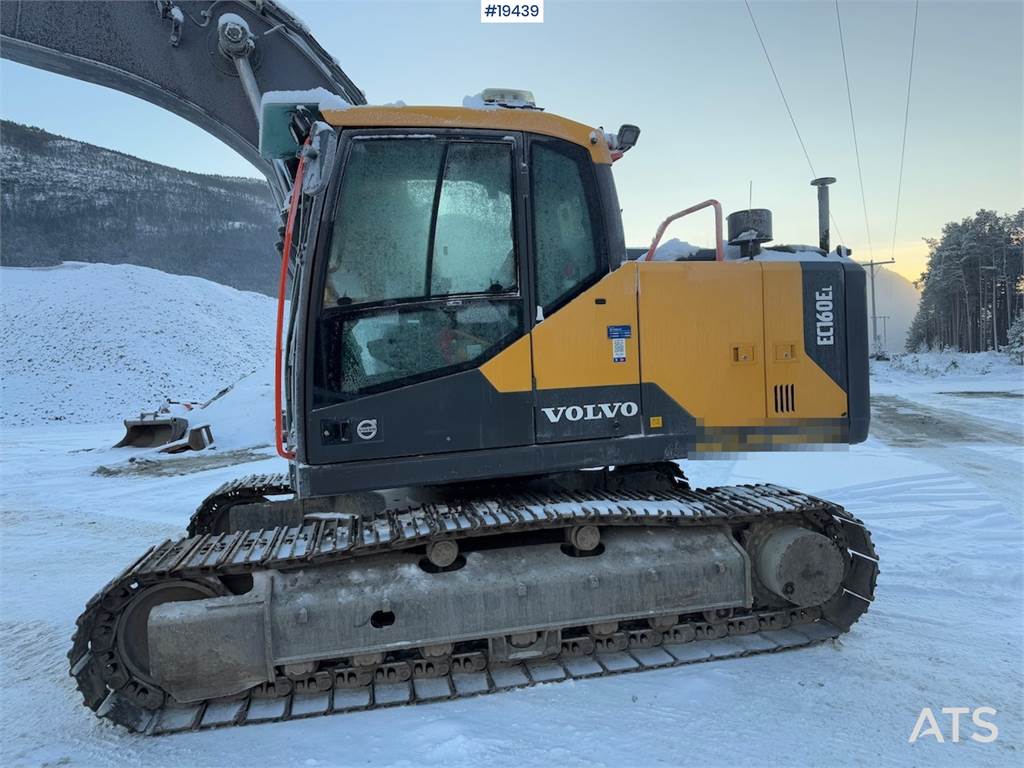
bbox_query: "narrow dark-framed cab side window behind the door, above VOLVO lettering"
[530,141,603,312]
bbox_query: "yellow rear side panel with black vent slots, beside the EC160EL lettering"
[761,262,847,421]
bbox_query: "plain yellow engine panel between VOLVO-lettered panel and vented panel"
[638,261,765,427]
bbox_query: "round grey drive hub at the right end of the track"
[754,525,846,607]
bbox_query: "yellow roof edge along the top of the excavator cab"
[323,106,611,165]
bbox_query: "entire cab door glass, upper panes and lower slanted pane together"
[313,137,523,407]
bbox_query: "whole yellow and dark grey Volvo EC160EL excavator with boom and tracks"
[0,0,879,734]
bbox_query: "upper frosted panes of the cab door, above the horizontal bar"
[324,137,518,309]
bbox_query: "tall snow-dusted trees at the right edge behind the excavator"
[906,209,1024,352]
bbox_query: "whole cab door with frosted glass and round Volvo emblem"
[303,129,534,464]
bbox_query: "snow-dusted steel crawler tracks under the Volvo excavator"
[69,476,878,733]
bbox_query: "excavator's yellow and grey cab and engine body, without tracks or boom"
[274,100,867,498]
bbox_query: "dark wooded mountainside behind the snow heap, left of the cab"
[0,121,280,294]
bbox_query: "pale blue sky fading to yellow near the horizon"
[0,0,1024,280]
